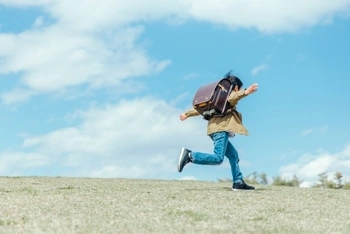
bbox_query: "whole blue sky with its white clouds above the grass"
[0,0,350,186]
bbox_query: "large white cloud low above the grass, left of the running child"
[0,97,212,178]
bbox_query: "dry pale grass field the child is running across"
[0,177,350,234]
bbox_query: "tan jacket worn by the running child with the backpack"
[185,89,248,136]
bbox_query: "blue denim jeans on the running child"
[191,132,243,183]
